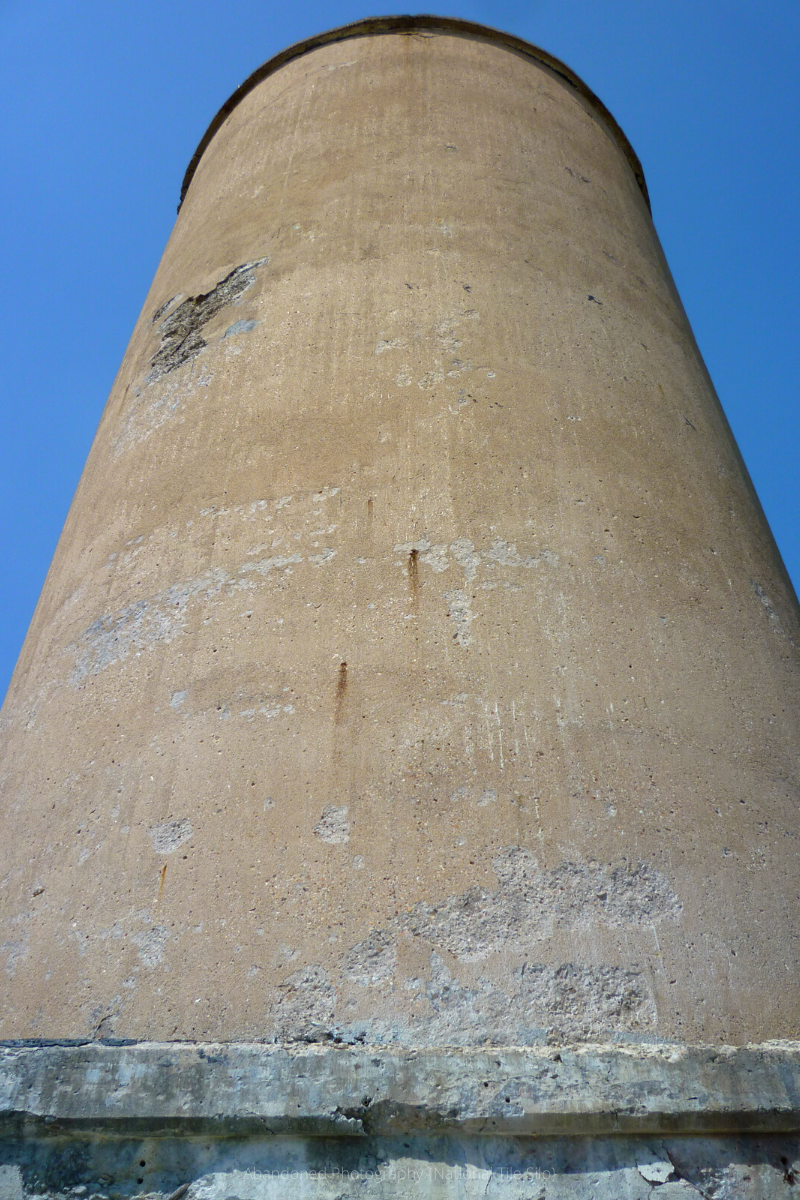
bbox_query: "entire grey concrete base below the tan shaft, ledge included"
[0,1043,800,1200]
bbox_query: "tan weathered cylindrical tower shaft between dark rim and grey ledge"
[0,21,800,1044]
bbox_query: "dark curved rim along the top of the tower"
[178,14,650,212]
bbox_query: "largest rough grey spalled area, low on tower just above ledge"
[307,854,681,1046]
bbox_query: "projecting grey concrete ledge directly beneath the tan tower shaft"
[0,1042,800,1138]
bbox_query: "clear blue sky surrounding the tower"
[0,0,800,695]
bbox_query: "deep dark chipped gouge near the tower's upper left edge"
[146,258,267,383]
